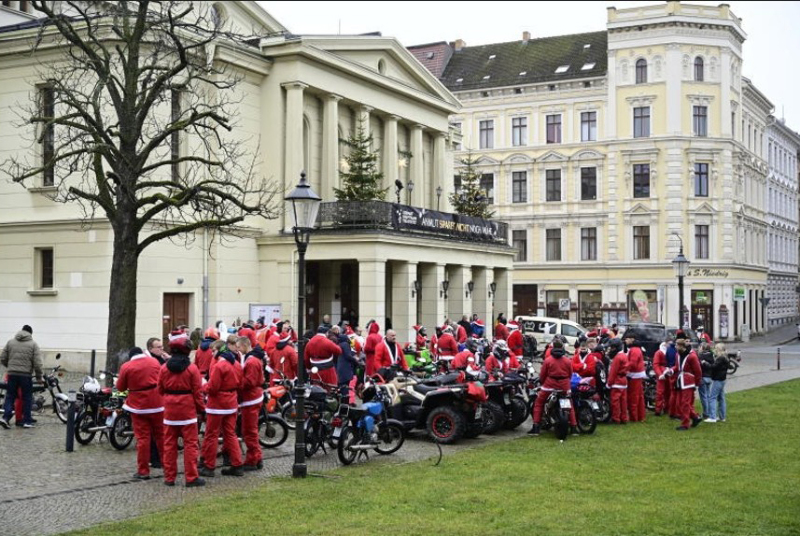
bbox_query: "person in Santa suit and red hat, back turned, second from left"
[158,342,206,488]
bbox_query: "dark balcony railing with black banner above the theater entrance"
[317,201,508,245]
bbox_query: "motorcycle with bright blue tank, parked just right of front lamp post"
[336,380,405,465]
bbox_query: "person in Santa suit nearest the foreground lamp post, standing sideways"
[236,337,266,471]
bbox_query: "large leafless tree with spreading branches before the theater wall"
[2,0,278,368]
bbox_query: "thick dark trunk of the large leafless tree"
[106,225,139,372]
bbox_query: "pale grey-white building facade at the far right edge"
[766,117,800,327]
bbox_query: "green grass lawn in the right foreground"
[70,380,800,536]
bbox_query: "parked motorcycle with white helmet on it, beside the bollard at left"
[75,370,133,450]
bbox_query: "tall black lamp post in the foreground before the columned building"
[285,171,322,478]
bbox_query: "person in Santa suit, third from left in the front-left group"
[200,350,244,477]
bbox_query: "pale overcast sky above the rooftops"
[259,1,800,131]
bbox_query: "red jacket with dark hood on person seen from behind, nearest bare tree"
[158,364,205,426]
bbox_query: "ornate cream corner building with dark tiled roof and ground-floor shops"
[411,1,792,340]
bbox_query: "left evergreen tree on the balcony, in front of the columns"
[333,117,388,201]
